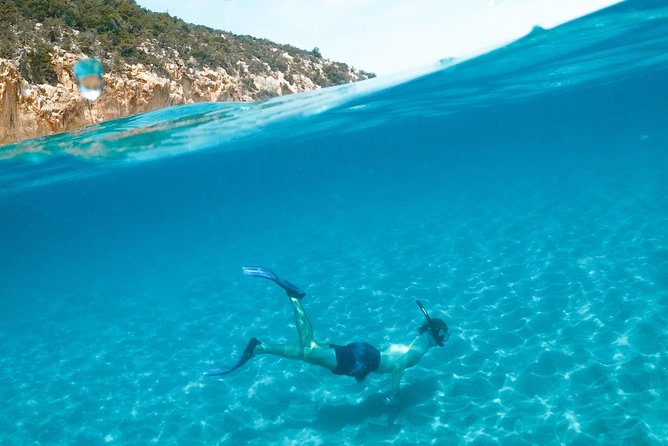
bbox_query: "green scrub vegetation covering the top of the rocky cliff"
[0,0,373,91]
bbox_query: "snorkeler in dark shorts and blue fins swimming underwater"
[205,267,449,401]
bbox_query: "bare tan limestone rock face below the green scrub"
[0,50,363,145]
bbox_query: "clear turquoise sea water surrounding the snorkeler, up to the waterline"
[0,2,668,445]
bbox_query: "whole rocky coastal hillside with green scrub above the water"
[0,0,373,145]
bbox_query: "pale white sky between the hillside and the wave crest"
[137,0,620,75]
